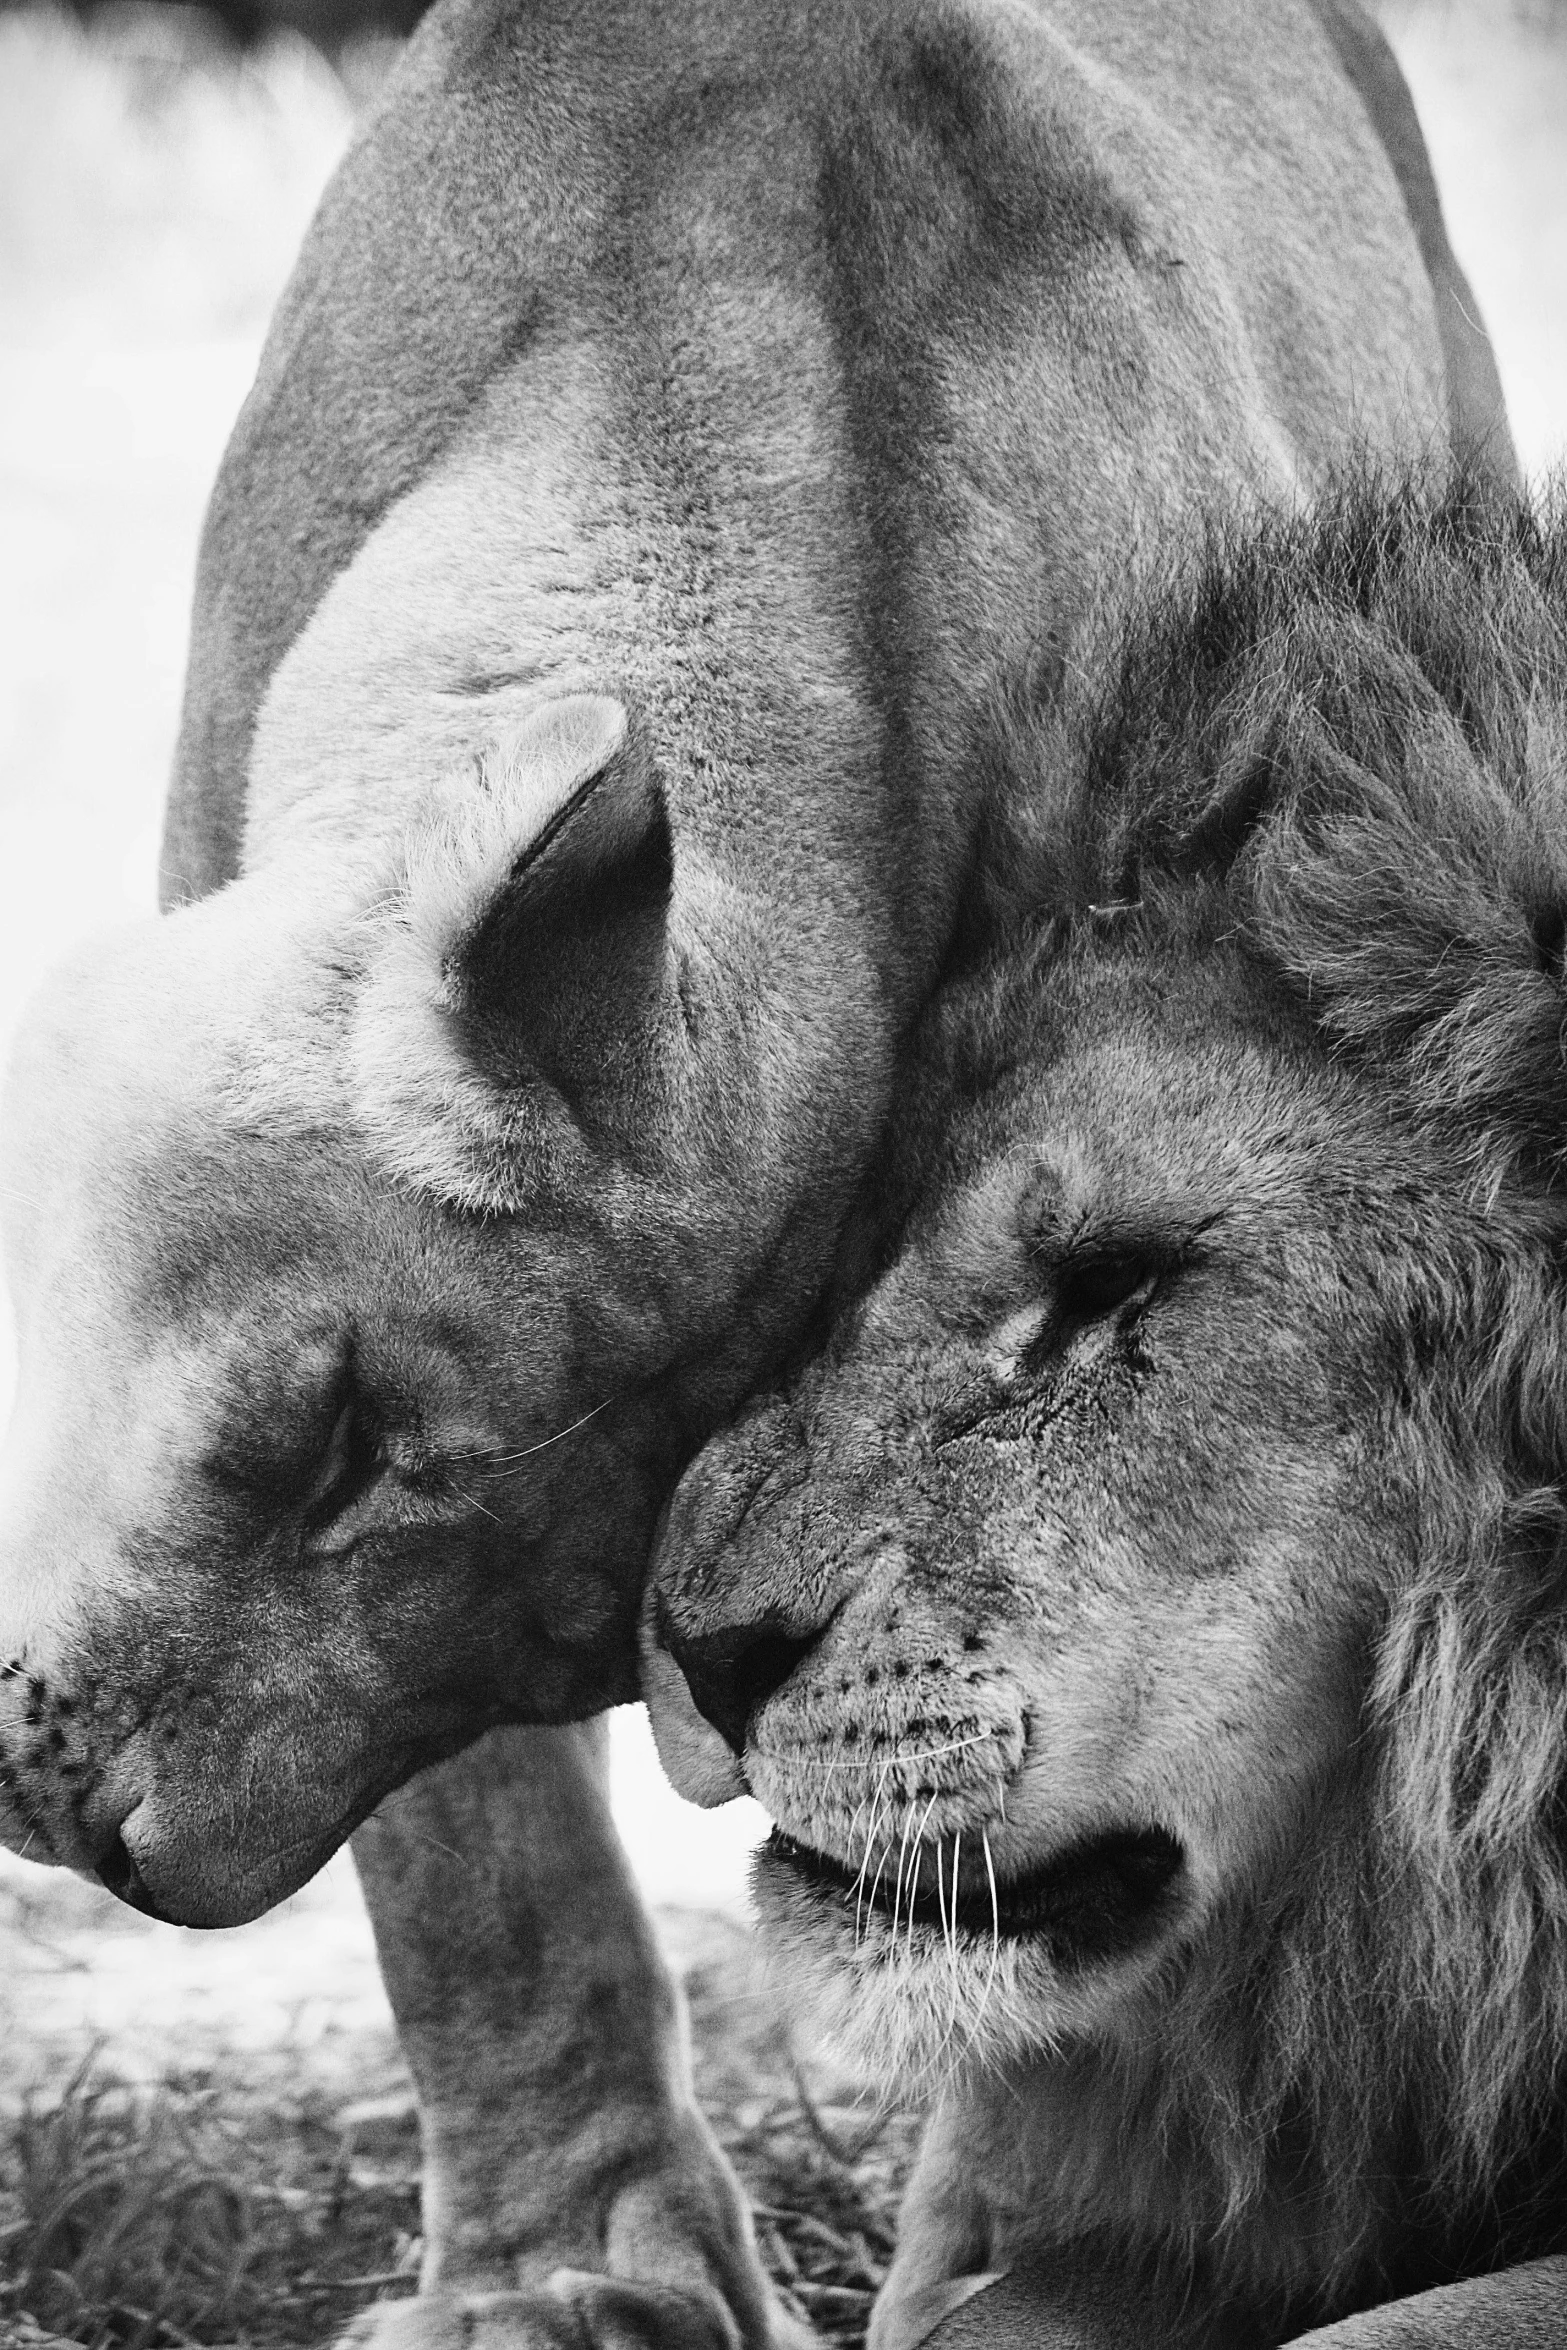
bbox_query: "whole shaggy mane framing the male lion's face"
[968,467,1567,2324]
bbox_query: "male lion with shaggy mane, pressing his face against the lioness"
[653,489,1567,2350]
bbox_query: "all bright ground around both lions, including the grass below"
[0,0,1567,2350]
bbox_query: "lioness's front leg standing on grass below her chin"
[352,1723,798,2350]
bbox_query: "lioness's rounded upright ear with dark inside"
[355,696,674,1208]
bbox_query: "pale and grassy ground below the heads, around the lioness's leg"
[0,1861,916,2350]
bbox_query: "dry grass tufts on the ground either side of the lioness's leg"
[0,1932,916,2350]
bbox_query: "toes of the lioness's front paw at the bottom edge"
[338,2268,796,2350]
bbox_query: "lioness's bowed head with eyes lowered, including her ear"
[0,696,831,1925]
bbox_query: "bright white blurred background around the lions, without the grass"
[0,0,1567,2274]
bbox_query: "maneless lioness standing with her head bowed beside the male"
[0,0,1511,2350]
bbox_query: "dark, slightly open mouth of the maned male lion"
[759,1828,1184,1967]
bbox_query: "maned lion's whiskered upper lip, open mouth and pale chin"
[745,1659,1184,2092]
